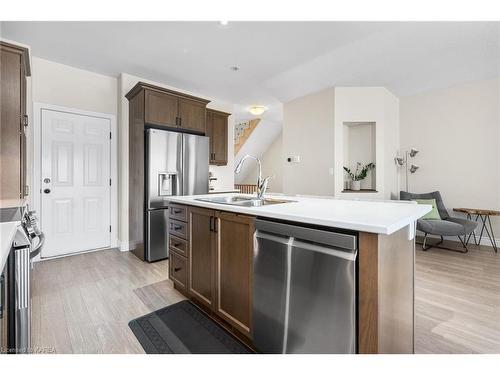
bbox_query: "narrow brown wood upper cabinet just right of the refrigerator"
[207,109,231,165]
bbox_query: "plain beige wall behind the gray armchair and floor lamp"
[400,78,500,239]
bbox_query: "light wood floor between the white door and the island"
[32,249,184,353]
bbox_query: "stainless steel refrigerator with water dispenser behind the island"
[144,129,209,262]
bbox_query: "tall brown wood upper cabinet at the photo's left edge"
[0,42,30,199]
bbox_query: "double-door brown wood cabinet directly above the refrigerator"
[125,82,210,134]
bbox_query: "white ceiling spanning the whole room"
[0,22,500,120]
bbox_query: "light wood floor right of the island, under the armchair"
[415,241,500,353]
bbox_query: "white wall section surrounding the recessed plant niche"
[334,87,399,199]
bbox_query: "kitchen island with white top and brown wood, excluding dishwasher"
[164,194,431,353]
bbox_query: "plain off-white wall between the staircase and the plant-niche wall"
[283,88,336,195]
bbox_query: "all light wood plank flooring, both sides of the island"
[32,247,500,353]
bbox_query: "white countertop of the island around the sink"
[169,194,432,234]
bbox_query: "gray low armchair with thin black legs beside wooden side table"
[400,191,477,253]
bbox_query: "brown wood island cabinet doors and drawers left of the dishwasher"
[169,205,254,338]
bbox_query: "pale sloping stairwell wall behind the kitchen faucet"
[242,134,283,193]
